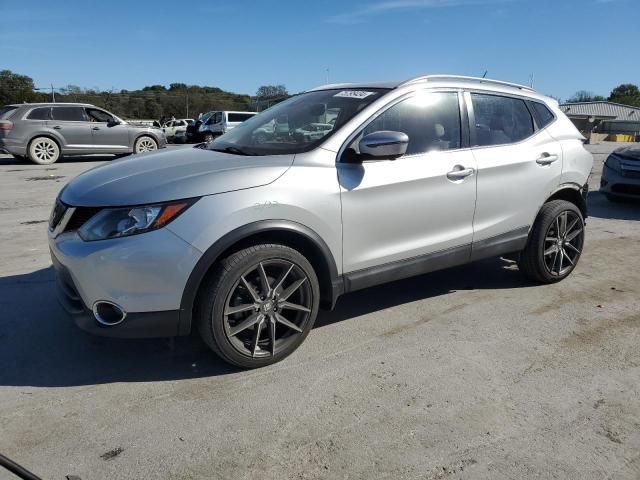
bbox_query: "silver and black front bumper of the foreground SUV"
[49,228,200,338]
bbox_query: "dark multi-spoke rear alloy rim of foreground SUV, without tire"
[543,210,584,277]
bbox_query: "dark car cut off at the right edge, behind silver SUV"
[600,146,640,202]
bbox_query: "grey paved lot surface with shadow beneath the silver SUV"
[0,144,640,480]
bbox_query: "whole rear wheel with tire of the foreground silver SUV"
[518,200,584,283]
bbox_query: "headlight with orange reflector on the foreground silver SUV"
[78,199,197,242]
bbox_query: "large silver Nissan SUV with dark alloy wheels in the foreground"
[49,76,593,368]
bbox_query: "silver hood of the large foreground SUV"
[60,148,294,207]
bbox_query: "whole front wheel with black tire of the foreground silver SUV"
[196,244,320,368]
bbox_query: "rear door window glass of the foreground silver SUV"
[471,93,533,146]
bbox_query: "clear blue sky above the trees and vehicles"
[0,0,640,99]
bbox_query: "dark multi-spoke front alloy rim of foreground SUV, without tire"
[223,259,313,358]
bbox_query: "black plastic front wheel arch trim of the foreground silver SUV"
[179,220,343,335]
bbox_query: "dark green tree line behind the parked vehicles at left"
[0,70,288,119]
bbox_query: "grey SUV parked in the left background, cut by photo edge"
[0,103,167,165]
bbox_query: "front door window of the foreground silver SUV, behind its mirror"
[363,93,460,155]
